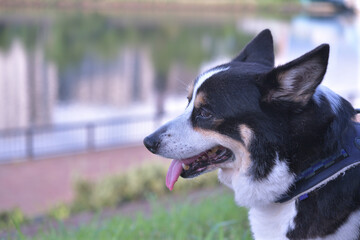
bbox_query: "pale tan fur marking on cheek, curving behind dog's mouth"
[194,128,251,172]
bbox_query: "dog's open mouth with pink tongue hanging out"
[166,146,234,190]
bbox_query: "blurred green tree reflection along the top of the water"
[0,12,251,108]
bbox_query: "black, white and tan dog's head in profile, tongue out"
[144,30,329,205]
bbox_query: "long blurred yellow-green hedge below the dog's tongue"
[71,164,218,212]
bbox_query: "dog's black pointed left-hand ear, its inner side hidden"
[232,29,274,67]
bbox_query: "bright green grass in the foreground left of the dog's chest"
[18,193,252,240]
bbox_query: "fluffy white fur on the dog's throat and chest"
[218,154,297,239]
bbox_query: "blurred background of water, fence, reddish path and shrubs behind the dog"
[0,0,360,237]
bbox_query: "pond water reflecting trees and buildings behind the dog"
[0,8,360,158]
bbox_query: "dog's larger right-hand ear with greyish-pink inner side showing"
[259,44,329,106]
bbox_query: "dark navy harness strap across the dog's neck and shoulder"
[276,109,360,203]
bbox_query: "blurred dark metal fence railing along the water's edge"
[0,113,175,163]
